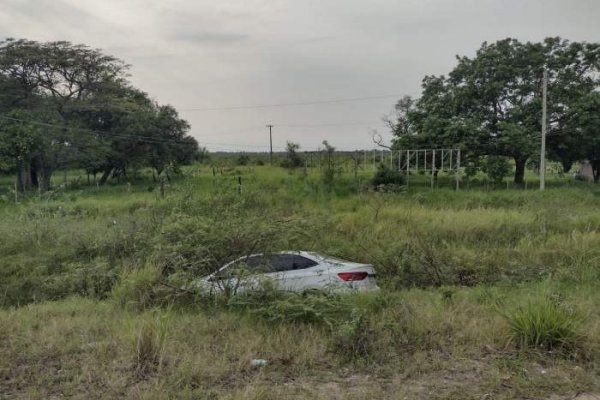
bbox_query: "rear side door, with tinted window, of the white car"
[267,254,329,292]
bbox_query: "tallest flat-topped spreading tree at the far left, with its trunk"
[0,39,126,190]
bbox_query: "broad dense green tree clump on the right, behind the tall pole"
[390,37,600,184]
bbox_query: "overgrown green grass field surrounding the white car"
[0,166,600,399]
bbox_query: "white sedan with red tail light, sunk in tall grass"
[194,251,379,293]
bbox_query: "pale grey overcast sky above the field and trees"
[0,0,600,151]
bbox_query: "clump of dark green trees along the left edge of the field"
[0,39,201,191]
